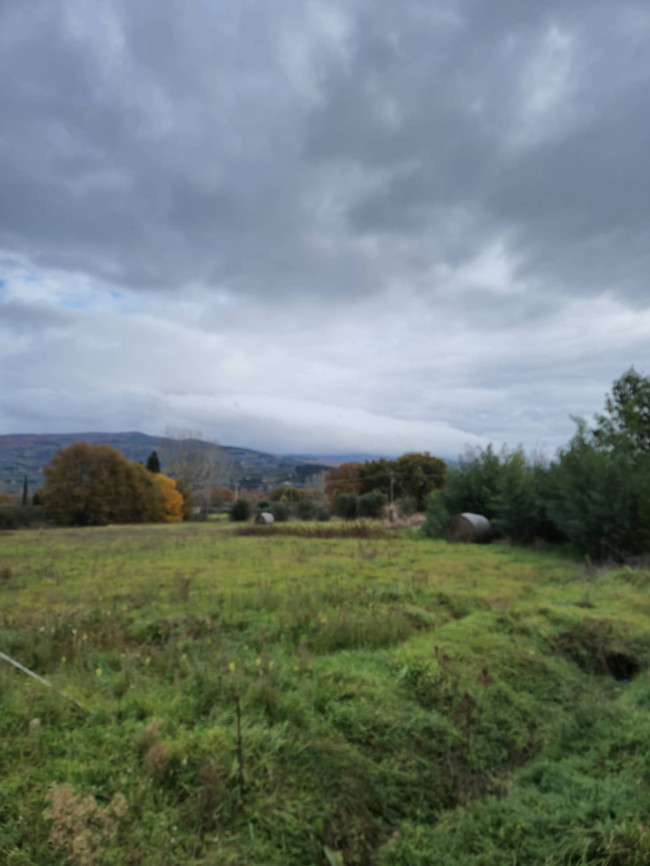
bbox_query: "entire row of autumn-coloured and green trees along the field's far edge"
[6,368,650,560]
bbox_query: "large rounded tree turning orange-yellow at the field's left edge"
[42,442,183,526]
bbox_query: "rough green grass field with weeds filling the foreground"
[0,522,650,866]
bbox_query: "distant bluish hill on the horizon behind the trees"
[0,432,332,493]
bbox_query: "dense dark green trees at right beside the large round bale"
[425,368,650,561]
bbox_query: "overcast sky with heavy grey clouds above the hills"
[0,0,650,456]
